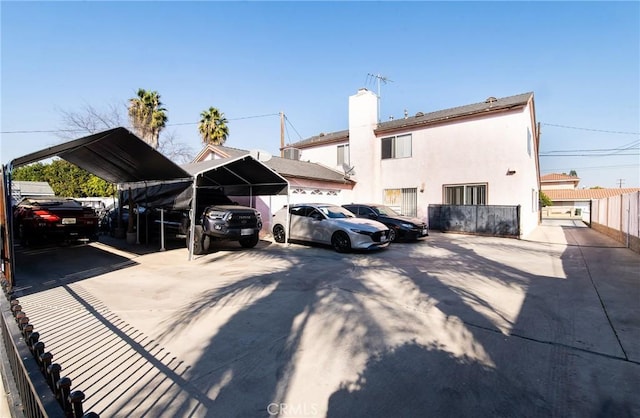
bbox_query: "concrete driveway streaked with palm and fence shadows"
[10,221,640,417]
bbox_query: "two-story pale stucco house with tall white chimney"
[284,89,539,235]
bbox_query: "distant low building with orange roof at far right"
[540,173,640,222]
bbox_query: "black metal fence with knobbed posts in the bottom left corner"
[0,273,98,418]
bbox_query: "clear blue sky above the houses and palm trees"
[0,1,640,187]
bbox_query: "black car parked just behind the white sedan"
[342,203,429,241]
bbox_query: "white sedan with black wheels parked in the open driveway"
[272,203,390,253]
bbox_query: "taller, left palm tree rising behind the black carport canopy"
[129,89,167,148]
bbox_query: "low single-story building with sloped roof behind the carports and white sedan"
[193,145,354,230]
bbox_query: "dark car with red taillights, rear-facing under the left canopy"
[13,197,98,246]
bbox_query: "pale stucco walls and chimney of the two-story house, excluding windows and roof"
[284,90,539,235]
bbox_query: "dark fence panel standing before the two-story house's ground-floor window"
[429,205,520,237]
